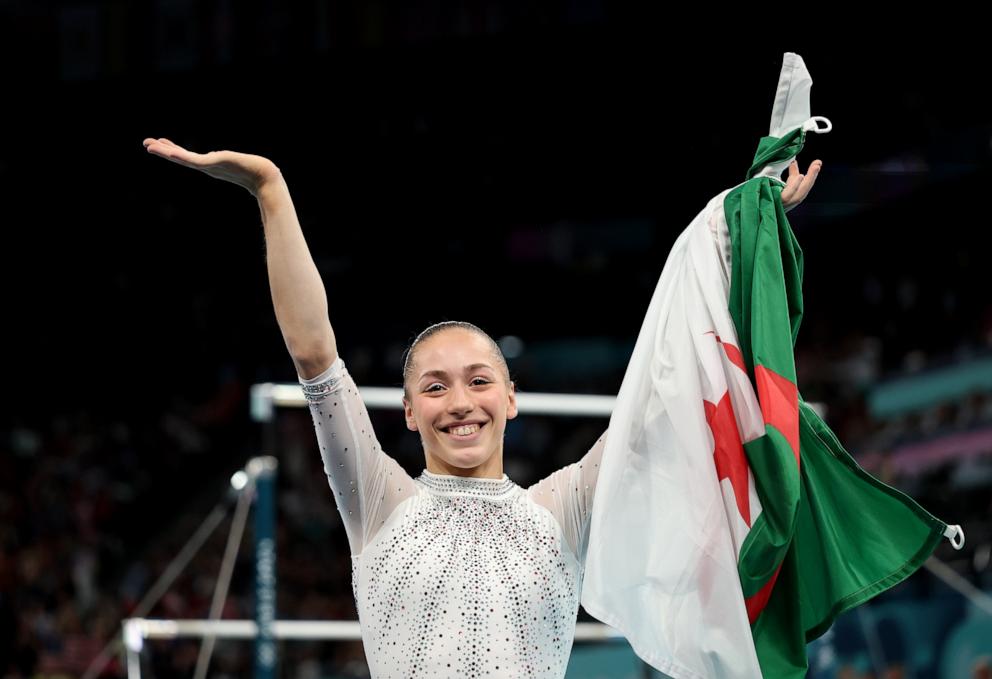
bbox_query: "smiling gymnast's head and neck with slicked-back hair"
[403,327,517,478]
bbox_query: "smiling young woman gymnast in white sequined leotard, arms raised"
[144,139,820,677]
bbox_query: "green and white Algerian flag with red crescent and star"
[581,54,960,679]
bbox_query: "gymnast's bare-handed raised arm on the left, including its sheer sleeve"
[144,138,416,554]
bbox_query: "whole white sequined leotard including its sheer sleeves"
[301,359,603,679]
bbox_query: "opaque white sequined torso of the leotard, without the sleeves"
[355,471,581,677]
